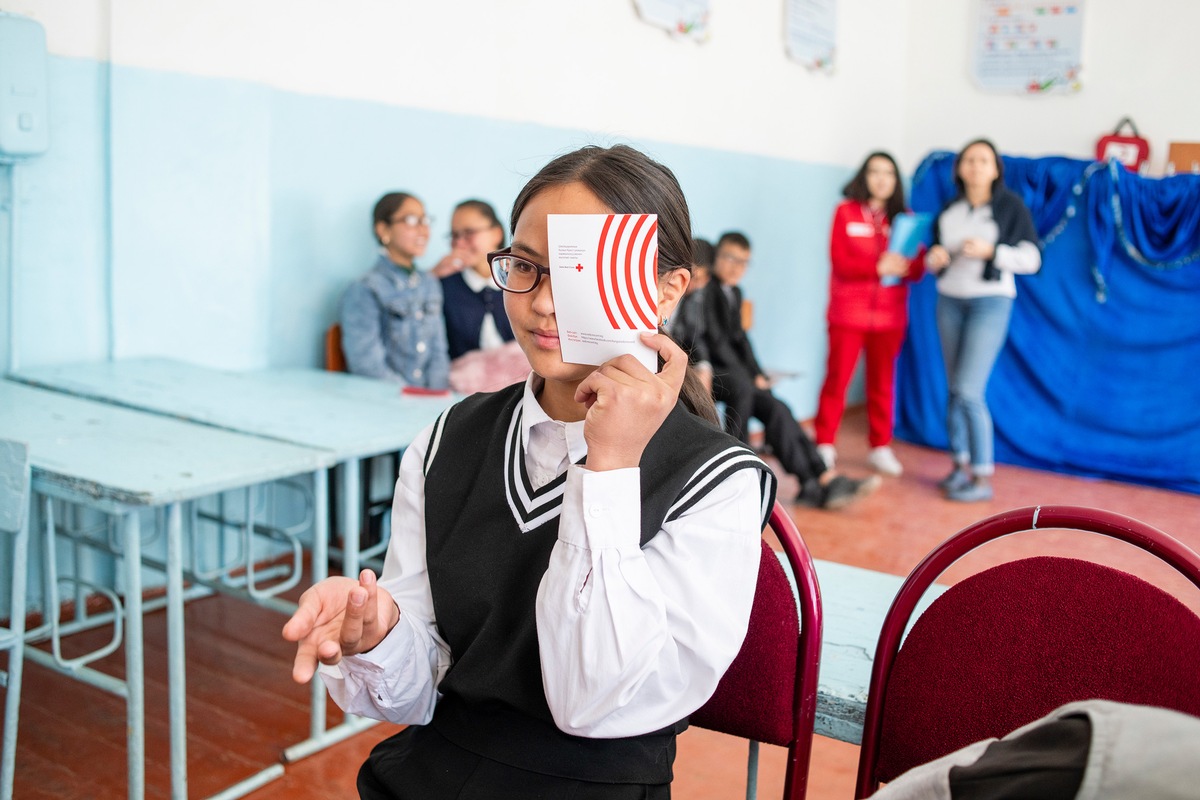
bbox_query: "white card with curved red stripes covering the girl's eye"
[546,213,659,372]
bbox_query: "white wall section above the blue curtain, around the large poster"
[900,0,1200,175]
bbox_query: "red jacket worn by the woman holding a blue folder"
[827,200,925,331]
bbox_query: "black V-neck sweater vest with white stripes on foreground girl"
[425,383,774,783]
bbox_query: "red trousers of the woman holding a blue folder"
[815,325,905,447]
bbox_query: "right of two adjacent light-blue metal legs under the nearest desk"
[167,503,187,800]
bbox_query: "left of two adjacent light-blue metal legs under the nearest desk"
[121,511,146,800]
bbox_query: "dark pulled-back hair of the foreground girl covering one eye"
[510,144,719,425]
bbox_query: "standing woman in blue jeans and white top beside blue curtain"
[925,139,1042,503]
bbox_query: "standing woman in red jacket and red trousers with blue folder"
[815,152,924,475]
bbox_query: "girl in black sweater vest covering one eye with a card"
[283,145,775,800]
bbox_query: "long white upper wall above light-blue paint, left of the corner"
[6,0,910,164]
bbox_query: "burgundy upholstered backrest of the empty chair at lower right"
[856,506,1200,798]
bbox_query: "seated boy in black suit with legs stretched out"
[704,231,880,509]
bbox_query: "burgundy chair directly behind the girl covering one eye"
[690,503,821,800]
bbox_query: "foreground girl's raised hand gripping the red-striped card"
[575,333,688,470]
